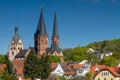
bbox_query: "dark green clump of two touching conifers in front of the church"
[24,51,51,80]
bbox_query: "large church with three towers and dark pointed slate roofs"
[8,9,63,61]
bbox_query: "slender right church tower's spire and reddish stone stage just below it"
[51,12,60,46]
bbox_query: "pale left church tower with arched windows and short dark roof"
[8,26,24,61]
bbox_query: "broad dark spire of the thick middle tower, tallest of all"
[36,8,47,36]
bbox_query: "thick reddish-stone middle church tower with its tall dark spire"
[34,9,48,56]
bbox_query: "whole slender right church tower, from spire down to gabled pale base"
[48,12,63,57]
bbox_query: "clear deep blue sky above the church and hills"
[0,0,120,54]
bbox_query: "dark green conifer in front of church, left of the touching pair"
[23,50,39,80]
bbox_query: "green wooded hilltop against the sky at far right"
[87,39,120,52]
